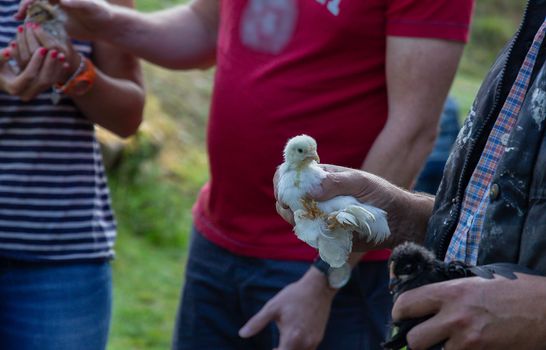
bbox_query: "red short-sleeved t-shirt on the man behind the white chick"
[193,0,473,261]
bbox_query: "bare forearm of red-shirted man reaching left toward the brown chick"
[100,3,217,69]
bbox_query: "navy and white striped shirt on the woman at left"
[0,0,116,261]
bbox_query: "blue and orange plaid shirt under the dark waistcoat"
[445,19,546,265]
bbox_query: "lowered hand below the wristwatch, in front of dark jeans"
[239,268,335,350]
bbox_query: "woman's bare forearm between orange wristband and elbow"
[72,68,144,137]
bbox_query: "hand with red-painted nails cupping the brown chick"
[0,47,67,101]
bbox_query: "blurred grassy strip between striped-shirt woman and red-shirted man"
[109,65,211,350]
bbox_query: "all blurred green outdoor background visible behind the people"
[104,0,526,350]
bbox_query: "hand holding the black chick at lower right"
[392,274,546,350]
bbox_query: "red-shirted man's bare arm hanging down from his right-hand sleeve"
[362,37,463,188]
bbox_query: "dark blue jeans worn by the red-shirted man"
[173,232,392,350]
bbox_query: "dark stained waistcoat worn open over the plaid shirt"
[427,0,546,273]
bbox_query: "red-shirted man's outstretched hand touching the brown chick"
[15,0,113,40]
